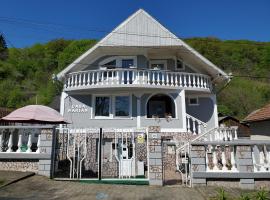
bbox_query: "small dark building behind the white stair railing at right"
[218,115,250,138]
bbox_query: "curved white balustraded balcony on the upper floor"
[64,68,212,92]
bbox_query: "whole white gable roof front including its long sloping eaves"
[57,9,229,80]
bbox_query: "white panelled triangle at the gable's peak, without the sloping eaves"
[99,9,183,46]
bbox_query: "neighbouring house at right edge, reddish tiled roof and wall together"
[244,103,270,140]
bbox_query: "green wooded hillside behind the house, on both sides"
[0,36,270,119]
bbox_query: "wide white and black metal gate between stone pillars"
[54,128,148,180]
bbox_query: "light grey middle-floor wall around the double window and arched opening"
[64,90,185,129]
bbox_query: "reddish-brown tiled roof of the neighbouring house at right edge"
[244,103,270,122]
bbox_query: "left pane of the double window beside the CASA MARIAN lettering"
[95,97,110,117]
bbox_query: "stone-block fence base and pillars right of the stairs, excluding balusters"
[190,141,270,189]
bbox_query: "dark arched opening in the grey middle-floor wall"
[147,94,175,118]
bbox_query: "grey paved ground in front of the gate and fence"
[0,175,249,200]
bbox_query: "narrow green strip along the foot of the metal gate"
[79,180,149,185]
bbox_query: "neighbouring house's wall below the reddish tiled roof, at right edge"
[250,120,270,140]
